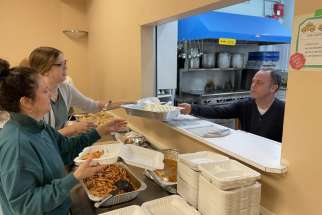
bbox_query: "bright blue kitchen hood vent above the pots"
[178,11,291,43]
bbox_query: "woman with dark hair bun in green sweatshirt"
[0,67,126,215]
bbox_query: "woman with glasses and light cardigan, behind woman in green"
[29,47,130,136]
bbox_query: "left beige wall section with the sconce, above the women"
[0,0,92,97]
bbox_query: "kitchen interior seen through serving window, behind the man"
[156,0,292,128]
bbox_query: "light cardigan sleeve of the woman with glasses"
[69,85,100,112]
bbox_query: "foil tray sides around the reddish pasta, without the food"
[81,162,147,207]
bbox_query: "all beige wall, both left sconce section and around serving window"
[0,0,322,215]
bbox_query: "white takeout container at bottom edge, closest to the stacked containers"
[142,195,200,215]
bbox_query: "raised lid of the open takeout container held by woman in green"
[120,144,164,170]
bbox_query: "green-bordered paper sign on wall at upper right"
[296,9,322,68]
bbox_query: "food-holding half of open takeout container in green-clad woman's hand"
[74,143,123,165]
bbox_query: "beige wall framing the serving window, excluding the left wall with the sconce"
[89,0,322,215]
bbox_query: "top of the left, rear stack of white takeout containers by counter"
[179,151,229,171]
